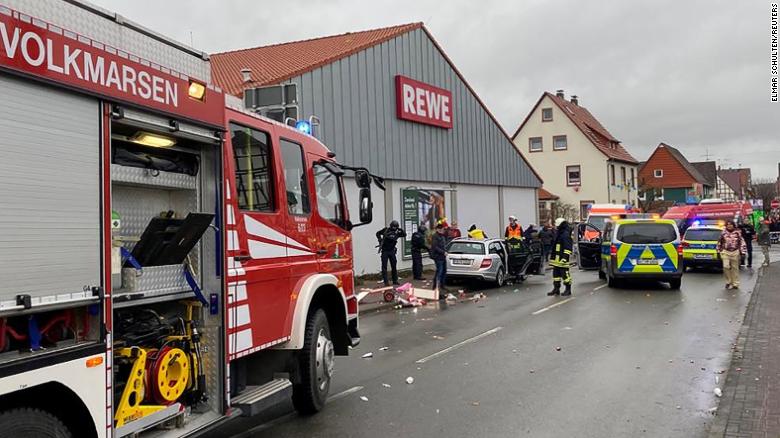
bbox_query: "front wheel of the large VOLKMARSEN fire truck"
[293,309,335,415]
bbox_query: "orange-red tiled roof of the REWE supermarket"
[211,23,423,96]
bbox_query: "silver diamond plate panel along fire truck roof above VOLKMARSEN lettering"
[3,0,211,81]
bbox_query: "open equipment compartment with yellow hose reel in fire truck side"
[110,108,225,437]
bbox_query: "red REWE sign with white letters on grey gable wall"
[395,75,452,129]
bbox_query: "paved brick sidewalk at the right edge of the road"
[709,263,780,438]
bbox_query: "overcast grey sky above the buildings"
[92,0,780,178]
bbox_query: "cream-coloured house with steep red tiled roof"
[512,90,639,219]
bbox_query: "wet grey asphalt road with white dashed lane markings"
[215,262,757,438]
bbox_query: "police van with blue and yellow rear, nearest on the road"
[599,218,683,289]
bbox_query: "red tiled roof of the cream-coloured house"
[512,92,639,164]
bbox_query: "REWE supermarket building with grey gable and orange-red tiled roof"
[211,23,542,275]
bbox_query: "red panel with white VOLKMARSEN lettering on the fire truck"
[0,6,225,125]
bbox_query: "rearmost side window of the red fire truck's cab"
[230,123,275,212]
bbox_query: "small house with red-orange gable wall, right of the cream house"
[639,143,714,204]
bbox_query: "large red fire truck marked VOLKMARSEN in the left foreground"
[0,0,382,438]
